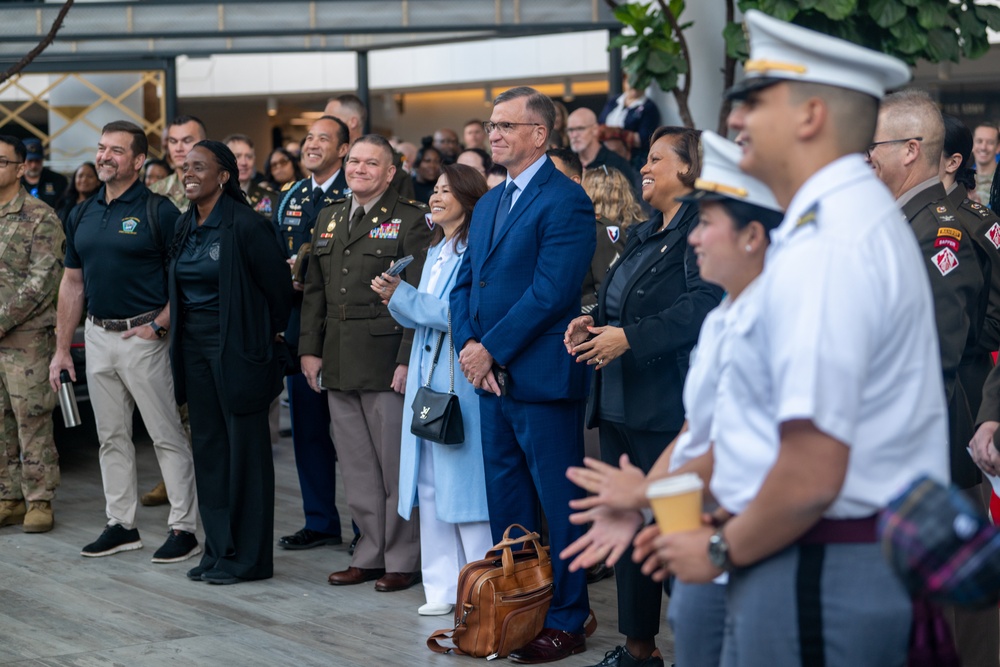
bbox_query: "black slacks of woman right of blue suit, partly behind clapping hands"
[599,419,677,639]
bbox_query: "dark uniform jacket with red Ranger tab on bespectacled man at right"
[902,182,989,488]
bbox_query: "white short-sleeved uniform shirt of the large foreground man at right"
[712,155,948,518]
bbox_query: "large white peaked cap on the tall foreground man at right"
[726,9,911,99]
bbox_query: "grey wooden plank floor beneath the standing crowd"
[0,404,672,667]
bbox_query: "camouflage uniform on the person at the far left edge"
[0,186,66,502]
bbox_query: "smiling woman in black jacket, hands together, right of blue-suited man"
[565,127,722,665]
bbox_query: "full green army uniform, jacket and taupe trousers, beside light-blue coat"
[299,186,431,576]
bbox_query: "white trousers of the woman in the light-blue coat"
[417,442,493,604]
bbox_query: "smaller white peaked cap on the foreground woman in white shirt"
[680,131,781,212]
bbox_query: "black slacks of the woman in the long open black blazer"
[180,311,274,579]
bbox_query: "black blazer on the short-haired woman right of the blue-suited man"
[587,204,722,431]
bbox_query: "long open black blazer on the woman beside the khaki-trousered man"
[168,195,292,414]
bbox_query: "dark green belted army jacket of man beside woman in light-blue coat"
[299,187,431,391]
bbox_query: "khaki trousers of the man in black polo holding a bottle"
[85,320,197,533]
